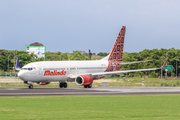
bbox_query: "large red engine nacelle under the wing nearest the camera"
[75,75,93,85]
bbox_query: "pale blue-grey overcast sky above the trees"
[0,0,180,53]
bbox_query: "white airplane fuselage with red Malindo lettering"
[18,60,108,82]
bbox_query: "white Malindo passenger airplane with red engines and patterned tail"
[16,26,169,89]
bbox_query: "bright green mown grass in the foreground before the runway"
[0,95,180,120]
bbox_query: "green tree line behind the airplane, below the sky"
[0,48,180,77]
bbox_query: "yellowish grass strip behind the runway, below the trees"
[0,77,180,87]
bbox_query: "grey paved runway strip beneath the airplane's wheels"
[0,87,180,96]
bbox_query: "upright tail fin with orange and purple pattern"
[105,26,126,72]
